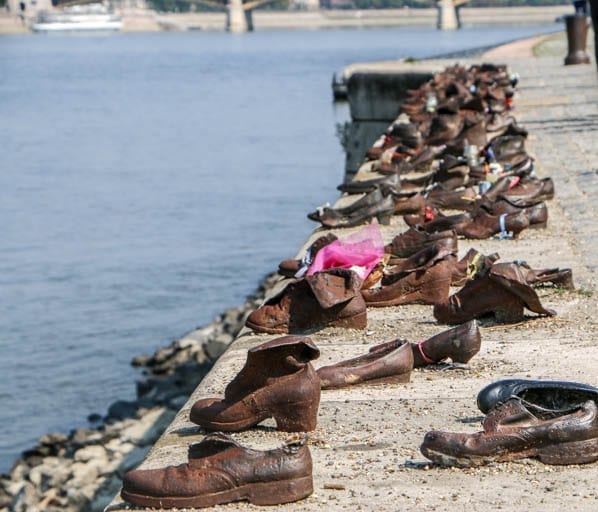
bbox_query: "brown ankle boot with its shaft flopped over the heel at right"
[434,262,556,324]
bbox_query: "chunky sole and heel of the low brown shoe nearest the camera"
[120,476,313,508]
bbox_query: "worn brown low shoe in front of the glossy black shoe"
[421,400,598,467]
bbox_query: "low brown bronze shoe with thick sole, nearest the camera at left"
[121,433,313,509]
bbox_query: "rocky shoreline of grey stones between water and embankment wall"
[0,273,279,512]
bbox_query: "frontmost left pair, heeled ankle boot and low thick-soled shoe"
[121,336,320,508]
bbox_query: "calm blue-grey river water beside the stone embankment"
[0,26,554,470]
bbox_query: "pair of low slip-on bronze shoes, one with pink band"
[317,320,481,389]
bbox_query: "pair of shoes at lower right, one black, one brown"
[421,379,598,467]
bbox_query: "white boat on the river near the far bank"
[31,4,122,33]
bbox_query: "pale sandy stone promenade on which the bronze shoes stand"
[108,32,598,512]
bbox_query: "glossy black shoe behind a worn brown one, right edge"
[477,379,598,414]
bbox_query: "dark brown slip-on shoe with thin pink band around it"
[411,320,482,368]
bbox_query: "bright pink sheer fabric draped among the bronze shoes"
[307,223,384,279]
